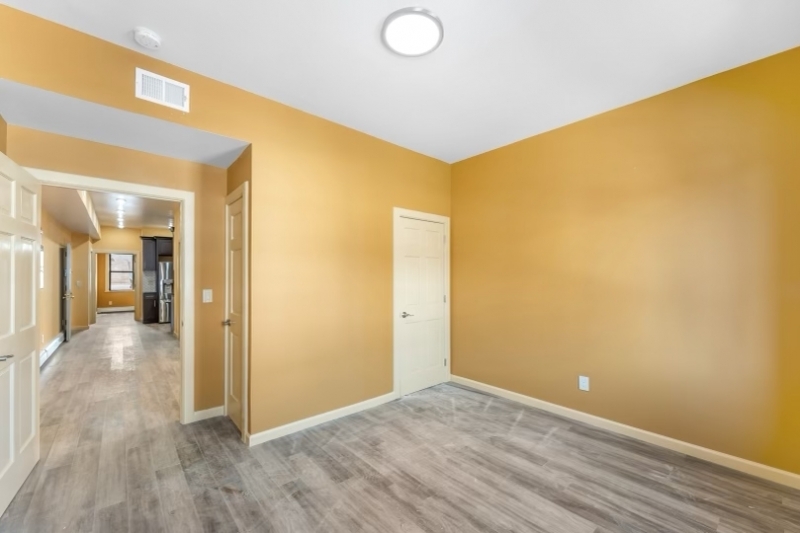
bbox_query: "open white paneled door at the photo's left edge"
[0,153,41,514]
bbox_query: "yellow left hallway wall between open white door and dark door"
[36,210,72,350]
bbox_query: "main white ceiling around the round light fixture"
[3,0,800,162]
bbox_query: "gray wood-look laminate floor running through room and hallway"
[0,315,800,533]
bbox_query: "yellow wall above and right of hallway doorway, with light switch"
[8,127,227,411]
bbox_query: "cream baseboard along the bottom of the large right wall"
[451,376,800,489]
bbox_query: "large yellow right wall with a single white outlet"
[452,44,800,473]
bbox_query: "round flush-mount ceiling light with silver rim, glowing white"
[381,7,444,57]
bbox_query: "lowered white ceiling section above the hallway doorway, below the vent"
[0,79,248,168]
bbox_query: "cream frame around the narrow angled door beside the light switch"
[223,182,250,444]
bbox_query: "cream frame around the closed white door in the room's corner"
[392,207,453,396]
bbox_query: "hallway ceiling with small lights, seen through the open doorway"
[89,191,180,228]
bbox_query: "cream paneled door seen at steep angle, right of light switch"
[224,183,248,441]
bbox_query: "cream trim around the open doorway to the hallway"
[26,168,195,424]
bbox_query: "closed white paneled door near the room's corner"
[394,210,450,395]
